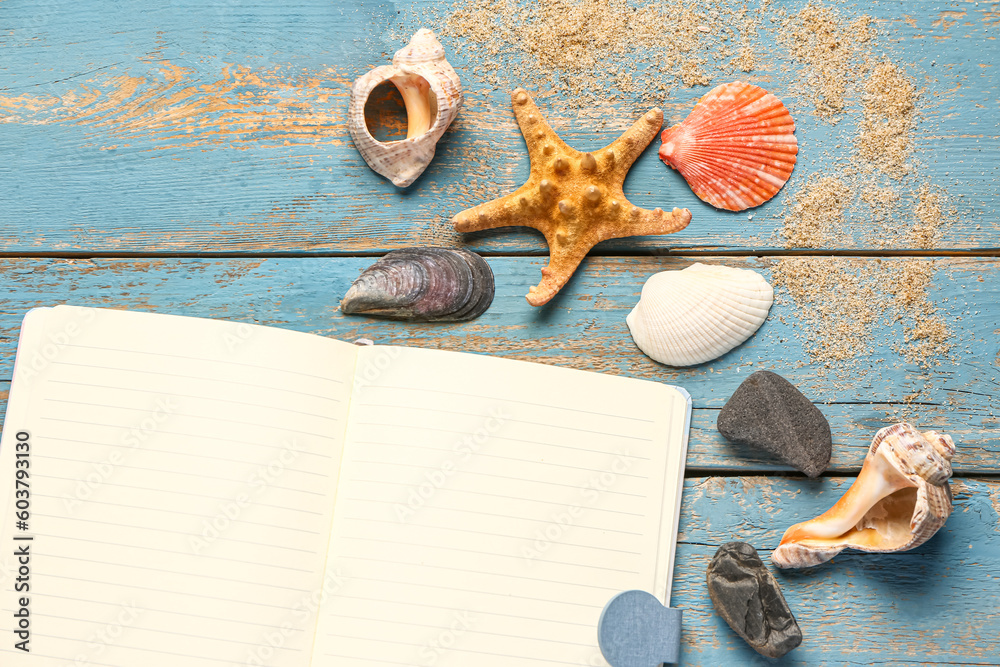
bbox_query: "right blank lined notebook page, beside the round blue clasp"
[313,346,687,667]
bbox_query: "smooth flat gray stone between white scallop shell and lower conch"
[718,371,833,477]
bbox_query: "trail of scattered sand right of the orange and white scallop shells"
[772,2,951,370]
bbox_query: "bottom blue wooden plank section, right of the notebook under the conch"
[672,477,1000,667]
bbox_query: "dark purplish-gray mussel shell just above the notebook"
[340,248,494,322]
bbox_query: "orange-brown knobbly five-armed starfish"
[452,88,691,306]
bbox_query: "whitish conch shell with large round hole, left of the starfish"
[347,28,463,188]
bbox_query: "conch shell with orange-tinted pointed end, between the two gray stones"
[771,422,955,568]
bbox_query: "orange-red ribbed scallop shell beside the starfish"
[660,81,799,211]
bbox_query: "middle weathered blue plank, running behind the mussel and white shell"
[0,257,1000,473]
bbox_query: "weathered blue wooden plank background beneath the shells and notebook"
[0,0,1000,666]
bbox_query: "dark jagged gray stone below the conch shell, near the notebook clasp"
[708,542,802,658]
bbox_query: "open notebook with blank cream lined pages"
[0,306,690,667]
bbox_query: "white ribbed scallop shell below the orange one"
[625,264,774,366]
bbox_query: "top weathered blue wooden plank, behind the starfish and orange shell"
[0,0,1000,254]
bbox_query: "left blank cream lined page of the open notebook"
[0,307,356,667]
